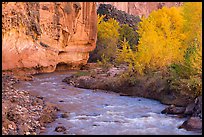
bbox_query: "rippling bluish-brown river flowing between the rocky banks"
[17,71,198,135]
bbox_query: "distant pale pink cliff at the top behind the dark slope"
[97,2,182,16]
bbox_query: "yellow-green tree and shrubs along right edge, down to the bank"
[170,2,202,97]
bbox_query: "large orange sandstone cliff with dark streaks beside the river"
[2,2,97,73]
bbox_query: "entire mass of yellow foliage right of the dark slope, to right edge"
[117,2,202,97]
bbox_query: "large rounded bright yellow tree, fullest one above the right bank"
[135,7,185,73]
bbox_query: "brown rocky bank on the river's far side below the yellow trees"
[63,64,202,132]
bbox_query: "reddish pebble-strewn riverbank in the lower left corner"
[2,74,59,135]
